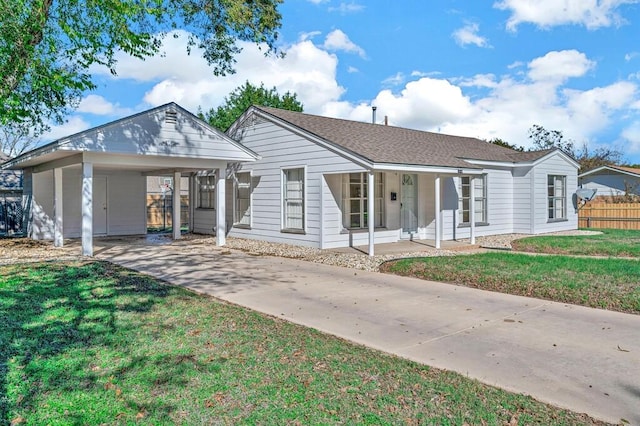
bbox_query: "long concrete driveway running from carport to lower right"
[96,242,640,425]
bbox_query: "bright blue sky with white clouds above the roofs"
[49,0,640,163]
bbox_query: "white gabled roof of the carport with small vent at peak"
[0,102,259,172]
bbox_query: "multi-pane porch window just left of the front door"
[342,173,384,229]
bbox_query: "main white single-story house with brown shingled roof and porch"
[226,106,579,254]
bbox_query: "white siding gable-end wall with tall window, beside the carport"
[229,121,367,247]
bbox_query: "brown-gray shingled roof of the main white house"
[255,106,552,168]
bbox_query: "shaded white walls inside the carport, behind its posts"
[31,168,147,240]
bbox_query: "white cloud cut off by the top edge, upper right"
[493,0,638,31]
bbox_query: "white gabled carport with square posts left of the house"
[2,103,258,256]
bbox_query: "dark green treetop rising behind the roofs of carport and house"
[198,81,303,132]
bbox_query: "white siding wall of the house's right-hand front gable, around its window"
[530,155,578,234]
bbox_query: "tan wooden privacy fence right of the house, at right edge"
[578,201,640,229]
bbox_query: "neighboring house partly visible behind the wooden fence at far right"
[578,166,640,197]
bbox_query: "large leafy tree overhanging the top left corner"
[0,0,282,133]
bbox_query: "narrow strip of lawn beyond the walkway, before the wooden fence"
[512,229,640,258]
